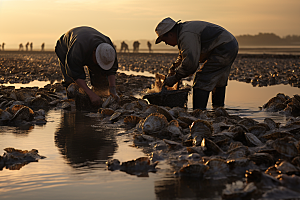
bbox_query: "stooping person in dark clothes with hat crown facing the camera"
[55,26,119,106]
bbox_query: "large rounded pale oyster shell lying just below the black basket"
[143,113,168,134]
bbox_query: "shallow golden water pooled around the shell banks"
[0,72,299,199]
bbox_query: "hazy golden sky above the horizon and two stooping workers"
[0,0,300,49]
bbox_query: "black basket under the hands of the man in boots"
[143,89,190,108]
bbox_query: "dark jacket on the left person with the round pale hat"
[55,26,118,80]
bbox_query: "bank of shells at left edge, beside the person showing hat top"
[0,84,65,126]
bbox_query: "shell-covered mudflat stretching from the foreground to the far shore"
[0,53,300,199]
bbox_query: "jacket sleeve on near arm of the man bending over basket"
[175,32,201,80]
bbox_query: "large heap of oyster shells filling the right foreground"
[93,97,300,198]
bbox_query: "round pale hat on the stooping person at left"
[95,43,116,70]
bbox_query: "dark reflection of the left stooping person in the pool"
[55,112,117,168]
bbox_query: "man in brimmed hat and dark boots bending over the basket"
[155,17,238,110]
